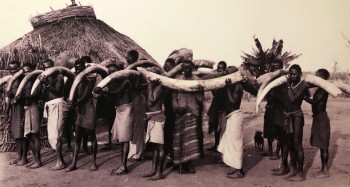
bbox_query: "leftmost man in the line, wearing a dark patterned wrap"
[5,61,28,166]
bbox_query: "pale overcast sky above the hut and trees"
[0,0,350,71]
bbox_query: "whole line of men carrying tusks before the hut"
[1,50,330,181]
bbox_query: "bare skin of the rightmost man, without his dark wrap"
[305,72,329,178]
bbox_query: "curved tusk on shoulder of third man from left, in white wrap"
[30,66,75,94]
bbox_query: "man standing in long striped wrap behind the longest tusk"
[172,60,204,174]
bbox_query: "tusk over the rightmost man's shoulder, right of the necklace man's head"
[303,75,342,97]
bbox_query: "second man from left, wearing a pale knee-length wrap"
[13,63,42,169]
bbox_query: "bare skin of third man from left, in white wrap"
[37,62,67,171]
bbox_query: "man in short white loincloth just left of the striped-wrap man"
[143,67,165,180]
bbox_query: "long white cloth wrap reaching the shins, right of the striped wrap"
[218,110,243,169]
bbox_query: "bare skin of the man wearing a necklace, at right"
[280,69,309,181]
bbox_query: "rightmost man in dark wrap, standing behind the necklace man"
[305,69,331,178]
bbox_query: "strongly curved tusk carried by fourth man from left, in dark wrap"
[68,64,108,101]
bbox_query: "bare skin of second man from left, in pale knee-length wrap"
[13,66,42,169]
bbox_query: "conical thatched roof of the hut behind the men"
[0,6,154,69]
